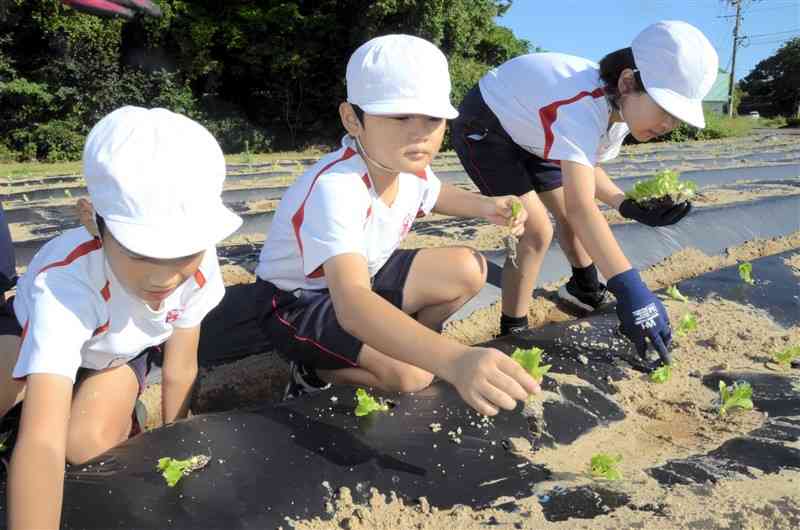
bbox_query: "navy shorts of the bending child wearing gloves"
[450,85,562,197]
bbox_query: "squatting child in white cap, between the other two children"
[254,35,538,414]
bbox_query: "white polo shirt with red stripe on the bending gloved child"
[479,53,630,167]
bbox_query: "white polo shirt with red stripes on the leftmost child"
[13,228,225,382]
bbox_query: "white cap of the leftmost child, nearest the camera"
[83,107,242,259]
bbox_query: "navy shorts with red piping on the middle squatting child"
[255,249,419,370]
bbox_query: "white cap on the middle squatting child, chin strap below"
[347,35,458,120]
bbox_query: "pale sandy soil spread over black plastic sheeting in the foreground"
[294,288,800,530]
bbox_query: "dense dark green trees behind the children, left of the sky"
[0,0,530,160]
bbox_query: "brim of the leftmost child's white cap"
[100,202,242,259]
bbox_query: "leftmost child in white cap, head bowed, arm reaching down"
[0,107,241,528]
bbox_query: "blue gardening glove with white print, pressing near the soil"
[608,269,672,364]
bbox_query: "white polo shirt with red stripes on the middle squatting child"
[256,137,442,291]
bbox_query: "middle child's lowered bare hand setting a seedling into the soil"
[447,347,540,416]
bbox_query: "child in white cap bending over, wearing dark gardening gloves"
[452,21,718,368]
